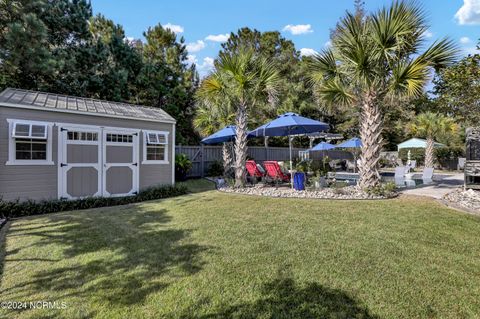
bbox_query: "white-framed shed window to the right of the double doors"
[142,131,169,164]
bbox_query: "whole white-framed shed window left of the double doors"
[6,119,54,165]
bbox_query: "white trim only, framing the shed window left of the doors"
[5,119,55,166]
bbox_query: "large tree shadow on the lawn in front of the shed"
[0,205,209,315]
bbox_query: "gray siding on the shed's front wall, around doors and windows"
[0,105,174,200]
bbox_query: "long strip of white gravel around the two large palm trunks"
[219,185,387,199]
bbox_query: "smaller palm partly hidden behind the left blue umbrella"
[193,99,235,176]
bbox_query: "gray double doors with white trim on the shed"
[58,124,140,199]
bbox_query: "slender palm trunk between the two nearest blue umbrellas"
[235,103,247,187]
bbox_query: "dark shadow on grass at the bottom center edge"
[181,276,378,319]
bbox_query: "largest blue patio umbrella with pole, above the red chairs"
[249,112,330,185]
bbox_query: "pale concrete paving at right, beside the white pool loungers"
[400,173,463,199]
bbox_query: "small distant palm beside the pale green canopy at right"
[408,112,458,167]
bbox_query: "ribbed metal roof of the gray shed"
[0,88,175,123]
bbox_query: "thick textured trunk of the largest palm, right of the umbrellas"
[358,91,383,189]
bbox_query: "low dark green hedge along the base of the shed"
[0,185,188,218]
